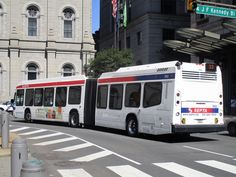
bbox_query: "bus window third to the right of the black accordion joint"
[125,84,141,107]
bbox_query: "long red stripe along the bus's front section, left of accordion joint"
[16,80,85,89]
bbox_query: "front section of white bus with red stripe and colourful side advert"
[14,75,96,127]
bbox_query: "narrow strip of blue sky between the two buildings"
[92,0,100,33]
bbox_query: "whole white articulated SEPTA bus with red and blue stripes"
[14,61,225,136]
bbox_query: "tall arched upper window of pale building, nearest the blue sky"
[63,8,75,38]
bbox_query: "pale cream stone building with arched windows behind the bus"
[0,0,95,102]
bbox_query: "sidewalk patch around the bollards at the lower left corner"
[0,133,17,177]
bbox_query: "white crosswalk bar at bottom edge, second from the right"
[154,162,213,177]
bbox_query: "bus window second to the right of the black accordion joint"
[109,84,123,109]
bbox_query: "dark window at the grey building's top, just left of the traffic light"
[161,0,176,15]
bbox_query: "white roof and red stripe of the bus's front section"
[16,75,87,89]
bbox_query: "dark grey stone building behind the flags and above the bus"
[99,0,190,64]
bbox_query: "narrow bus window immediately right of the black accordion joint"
[97,85,108,109]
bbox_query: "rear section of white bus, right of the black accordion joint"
[95,61,225,135]
